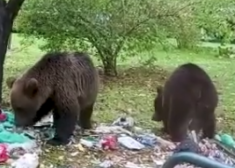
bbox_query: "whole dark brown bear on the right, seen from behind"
[152,63,218,142]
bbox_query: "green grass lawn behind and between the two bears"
[3,35,235,133]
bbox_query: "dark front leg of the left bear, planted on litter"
[47,104,79,146]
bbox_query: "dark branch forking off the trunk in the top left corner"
[6,0,25,19]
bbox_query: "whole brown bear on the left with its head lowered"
[7,52,98,145]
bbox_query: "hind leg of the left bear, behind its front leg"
[78,104,94,129]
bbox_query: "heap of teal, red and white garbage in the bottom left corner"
[0,110,40,168]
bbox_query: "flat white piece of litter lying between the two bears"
[118,136,145,150]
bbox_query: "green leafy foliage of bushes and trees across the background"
[14,0,233,75]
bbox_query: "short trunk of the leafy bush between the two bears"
[102,56,117,77]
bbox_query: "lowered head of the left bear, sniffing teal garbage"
[7,77,41,127]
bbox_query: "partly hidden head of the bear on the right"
[152,86,163,121]
